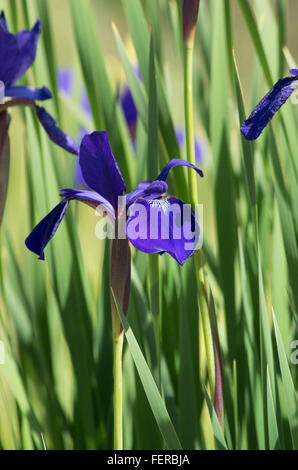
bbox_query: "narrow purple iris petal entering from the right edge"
[241,69,298,140]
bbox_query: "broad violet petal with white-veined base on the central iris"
[126,196,200,265]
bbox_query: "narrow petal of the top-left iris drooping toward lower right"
[35,106,79,155]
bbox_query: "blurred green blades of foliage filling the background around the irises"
[0,0,298,449]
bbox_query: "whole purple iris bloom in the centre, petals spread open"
[25,131,203,265]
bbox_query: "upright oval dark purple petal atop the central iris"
[79,131,125,207]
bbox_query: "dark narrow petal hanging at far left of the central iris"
[25,200,68,260]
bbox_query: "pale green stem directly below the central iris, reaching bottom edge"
[113,315,124,450]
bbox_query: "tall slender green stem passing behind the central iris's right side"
[184,39,216,398]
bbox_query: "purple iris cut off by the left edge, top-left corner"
[0,11,78,154]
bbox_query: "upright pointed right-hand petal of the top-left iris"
[13,20,40,83]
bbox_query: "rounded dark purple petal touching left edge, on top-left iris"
[0,23,21,86]
